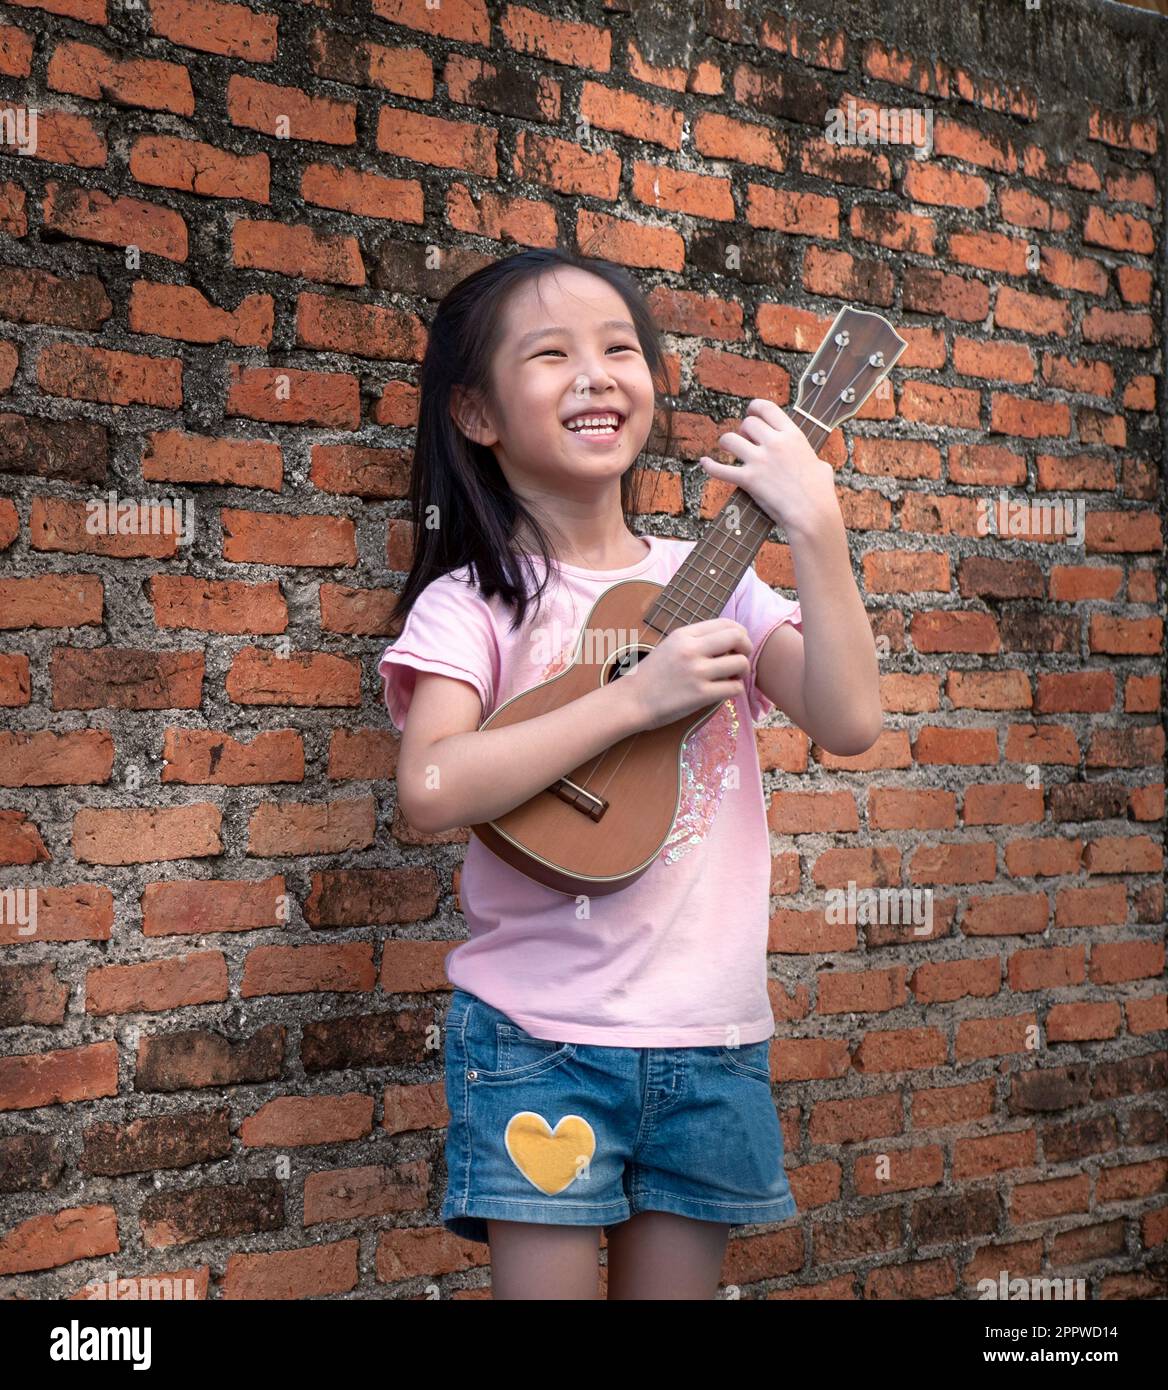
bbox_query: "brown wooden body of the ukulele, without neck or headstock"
[470,580,723,895]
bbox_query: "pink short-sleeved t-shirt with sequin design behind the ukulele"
[378,537,802,1047]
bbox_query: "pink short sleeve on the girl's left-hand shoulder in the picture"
[377,574,499,731]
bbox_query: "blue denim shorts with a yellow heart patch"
[441,988,798,1241]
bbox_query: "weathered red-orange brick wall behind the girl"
[0,0,1168,1298]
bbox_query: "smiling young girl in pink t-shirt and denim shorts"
[378,250,880,1298]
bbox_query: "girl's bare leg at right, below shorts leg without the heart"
[608,1212,730,1300]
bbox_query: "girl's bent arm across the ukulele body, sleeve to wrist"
[398,671,644,835]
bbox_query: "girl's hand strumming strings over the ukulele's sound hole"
[620,617,754,730]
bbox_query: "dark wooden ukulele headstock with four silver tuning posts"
[794,307,908,434]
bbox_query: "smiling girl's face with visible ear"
[464,267,654,496]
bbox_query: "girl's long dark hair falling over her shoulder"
[391,247,673,631]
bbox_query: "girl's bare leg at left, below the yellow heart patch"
[487,1220,601,1298]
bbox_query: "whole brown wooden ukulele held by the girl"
[470,307,908,897]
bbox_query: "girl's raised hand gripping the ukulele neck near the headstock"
[698,398,840,537]
